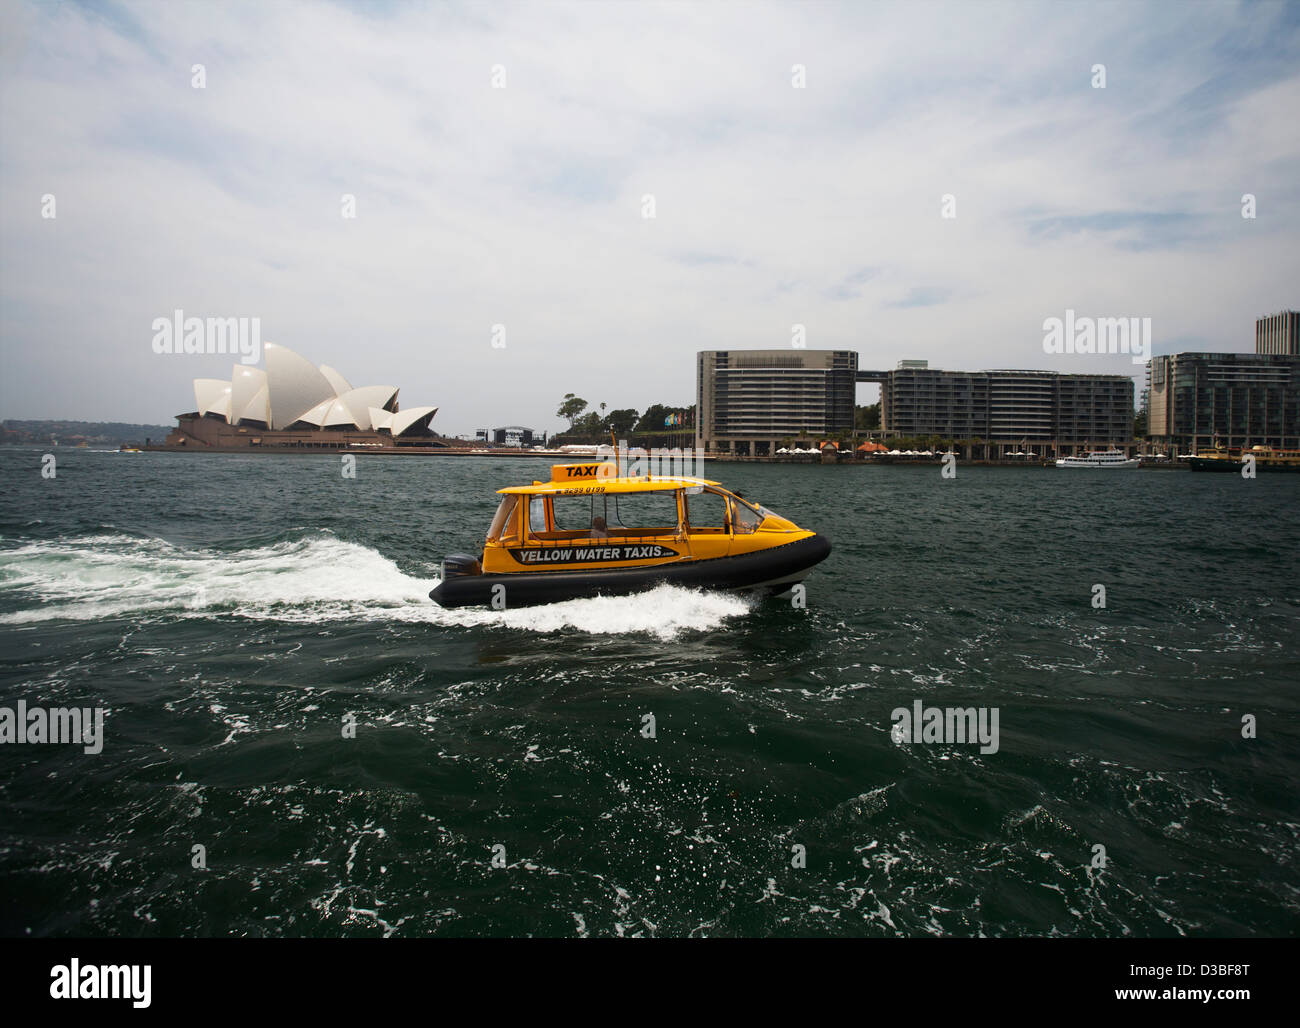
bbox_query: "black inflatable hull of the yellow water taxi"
[429,535,831,607]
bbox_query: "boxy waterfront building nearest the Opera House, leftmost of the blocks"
[696,350,858,456]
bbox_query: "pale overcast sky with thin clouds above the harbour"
[0,0,1300,434]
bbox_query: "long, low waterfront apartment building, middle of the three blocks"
[878,361,1134,456]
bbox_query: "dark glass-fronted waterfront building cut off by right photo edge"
[1147,350,1300,456]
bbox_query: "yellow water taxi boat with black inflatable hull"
[429,461,831,608]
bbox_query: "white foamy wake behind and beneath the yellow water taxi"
[0,533,753,638]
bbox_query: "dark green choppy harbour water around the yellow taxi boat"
[0,451,1300,936]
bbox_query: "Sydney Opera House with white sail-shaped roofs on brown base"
[161,343,439,450]
